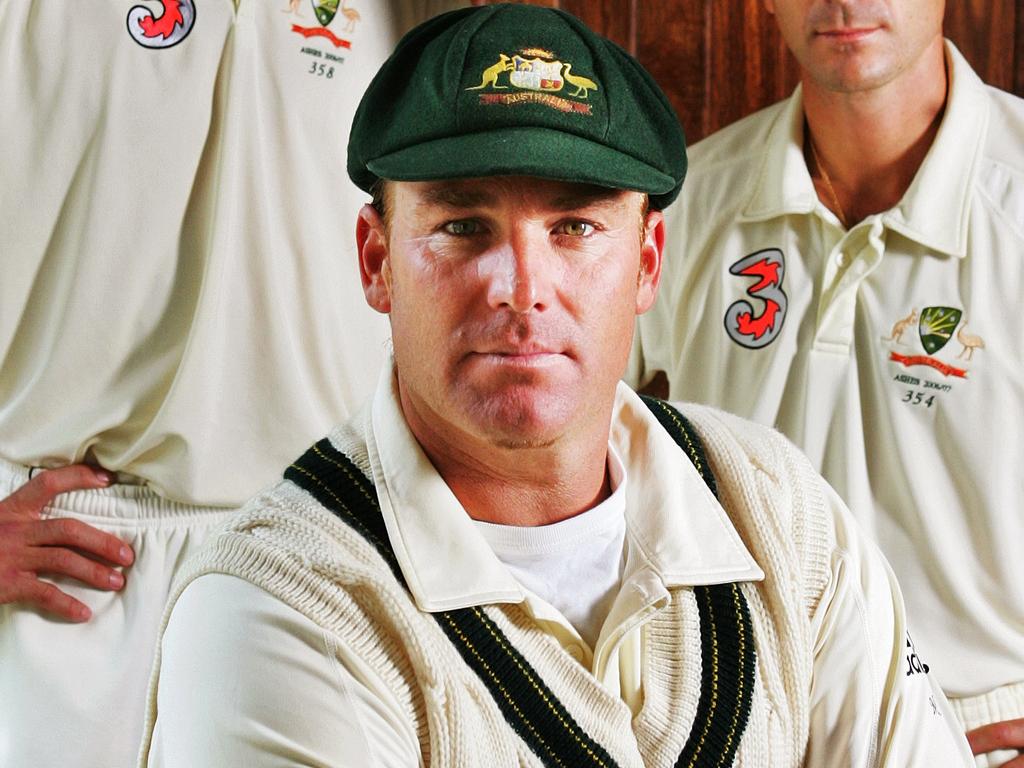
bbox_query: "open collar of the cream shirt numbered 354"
[739,40,988,257]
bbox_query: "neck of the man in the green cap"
[401,387,611,526]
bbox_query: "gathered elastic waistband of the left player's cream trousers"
[0,459,234,521]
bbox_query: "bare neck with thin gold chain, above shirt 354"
[802,38,947,227]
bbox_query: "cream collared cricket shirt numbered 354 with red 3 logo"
[628,43,1024,695]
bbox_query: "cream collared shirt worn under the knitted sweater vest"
[148,364,969,768]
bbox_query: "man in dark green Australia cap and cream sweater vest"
[140,4,971,768]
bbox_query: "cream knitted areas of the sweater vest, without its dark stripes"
[143,406,835,768]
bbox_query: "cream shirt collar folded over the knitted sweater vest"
[366,366,764,611]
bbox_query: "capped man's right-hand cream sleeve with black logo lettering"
[806,487,975,768]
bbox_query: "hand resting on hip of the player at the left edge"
[0,464,135,622]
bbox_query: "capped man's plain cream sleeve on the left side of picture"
[142,573,422,768]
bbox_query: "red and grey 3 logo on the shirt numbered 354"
[725,248,788,349]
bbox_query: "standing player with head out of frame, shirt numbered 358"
[0,0,455,768]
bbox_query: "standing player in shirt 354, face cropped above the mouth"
[627,0,1024,766]
